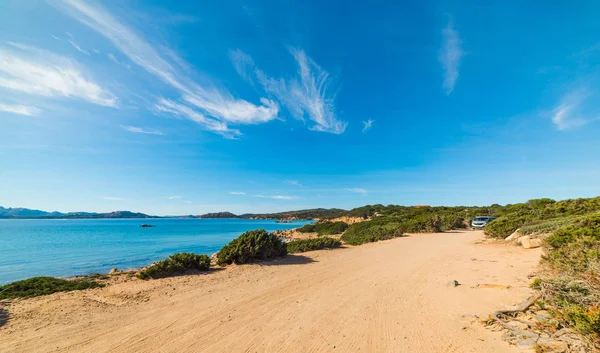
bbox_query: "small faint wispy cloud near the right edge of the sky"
[552,89,599,131]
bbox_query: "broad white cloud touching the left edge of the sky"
[0,42,117,107]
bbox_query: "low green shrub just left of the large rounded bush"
[137,253,210,279]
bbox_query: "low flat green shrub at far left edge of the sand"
[0,277,104,299]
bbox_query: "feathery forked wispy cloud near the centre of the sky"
[230,49,348,134]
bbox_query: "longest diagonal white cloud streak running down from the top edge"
[59,0,279,137]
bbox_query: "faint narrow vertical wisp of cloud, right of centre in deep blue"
[438,21,464,95]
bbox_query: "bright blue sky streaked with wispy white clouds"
[0,0,600,215]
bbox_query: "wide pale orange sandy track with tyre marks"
[0,231,540,353]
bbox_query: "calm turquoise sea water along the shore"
[0,218,307,284]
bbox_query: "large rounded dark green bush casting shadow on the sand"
[217,229,287,266]
